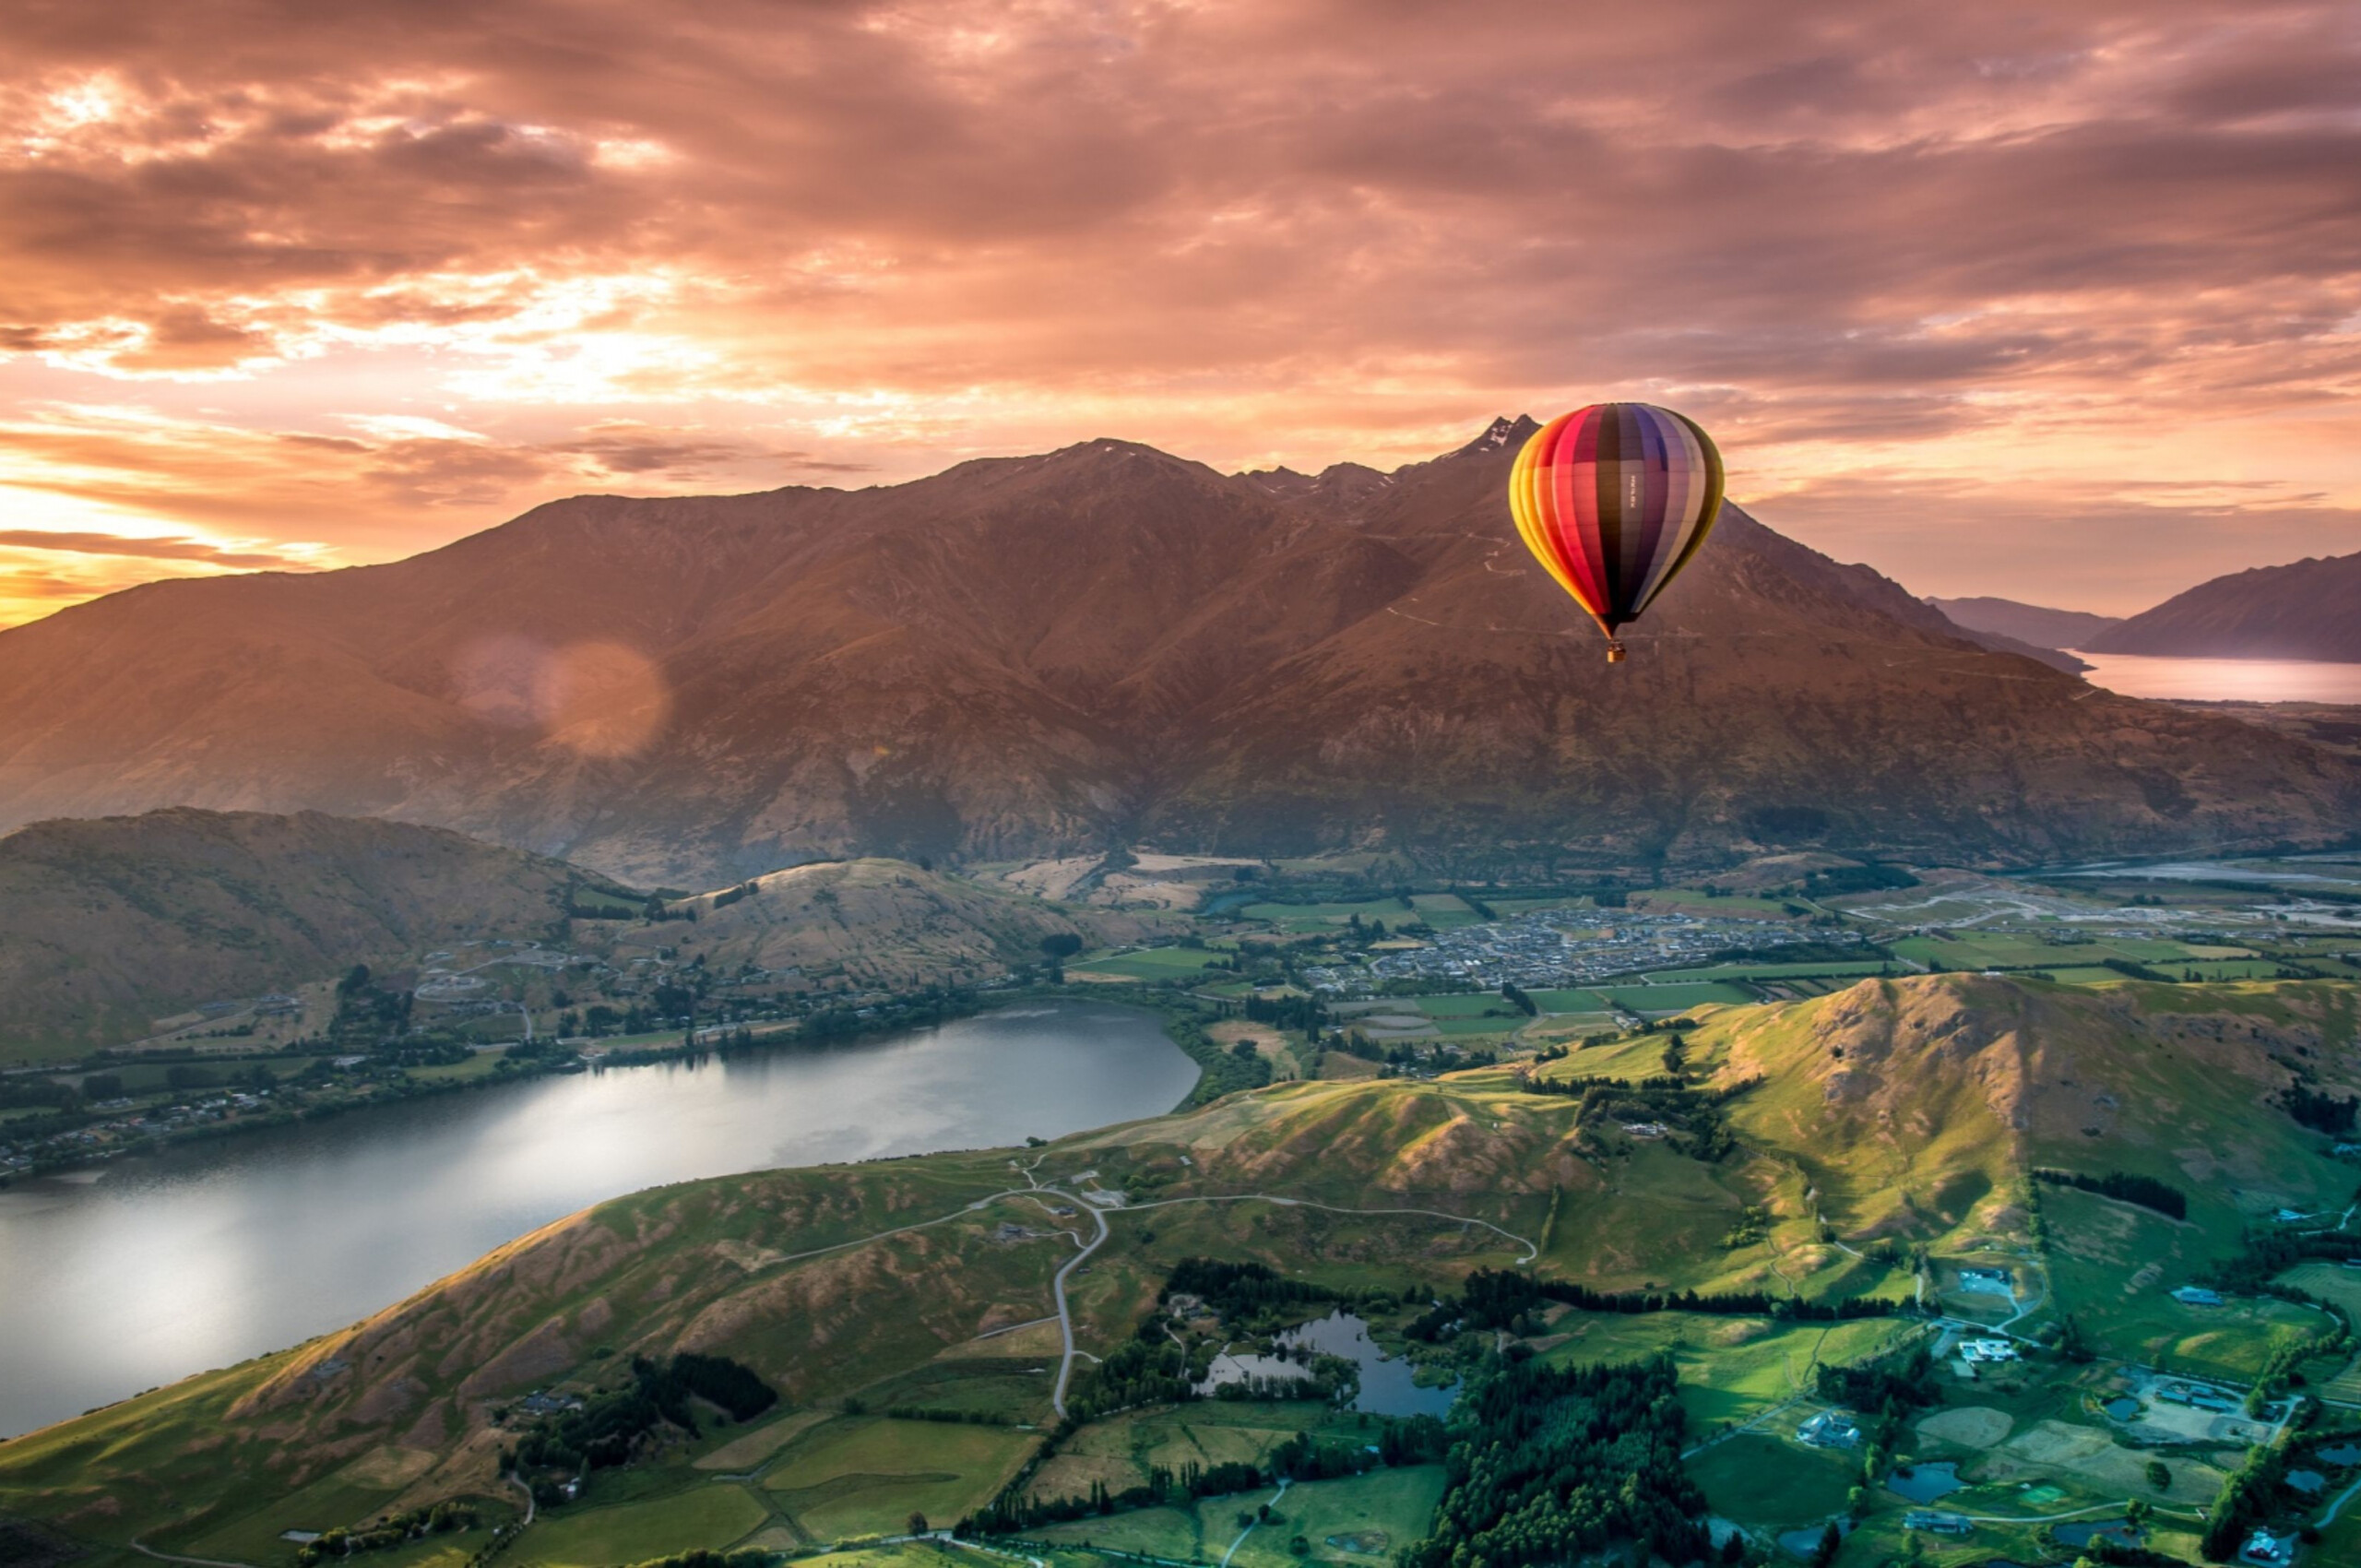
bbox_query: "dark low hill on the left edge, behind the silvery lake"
[0,808,637,1055]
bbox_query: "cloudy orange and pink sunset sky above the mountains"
[0,0,2361,624]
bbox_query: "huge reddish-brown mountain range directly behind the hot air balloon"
[0,421,2356,885]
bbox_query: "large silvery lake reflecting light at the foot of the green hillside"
[0,1002,1197,1436]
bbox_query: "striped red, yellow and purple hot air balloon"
[1509,404,1721,663]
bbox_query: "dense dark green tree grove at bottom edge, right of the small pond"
[1398,1356,1742,1568]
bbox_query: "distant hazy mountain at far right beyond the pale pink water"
[2087,552,2361,663]
